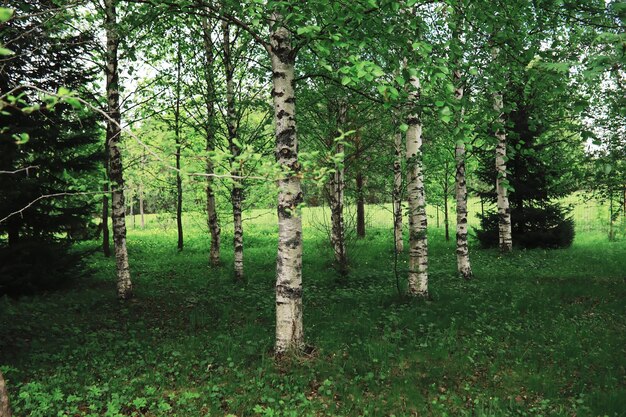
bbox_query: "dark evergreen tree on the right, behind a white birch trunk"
[476,79,583,248]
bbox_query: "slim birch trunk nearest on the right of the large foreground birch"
[328,102,348,275]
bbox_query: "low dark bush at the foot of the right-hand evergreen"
[475,204,575,249]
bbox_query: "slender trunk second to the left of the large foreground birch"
[202,17,221,266]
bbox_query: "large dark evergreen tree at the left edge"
[0,0,102,293]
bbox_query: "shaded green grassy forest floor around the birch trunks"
[0,206,626,417]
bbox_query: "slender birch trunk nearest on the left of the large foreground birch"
[222,22,244,281]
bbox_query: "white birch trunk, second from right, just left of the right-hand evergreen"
[454,69,472,280]
